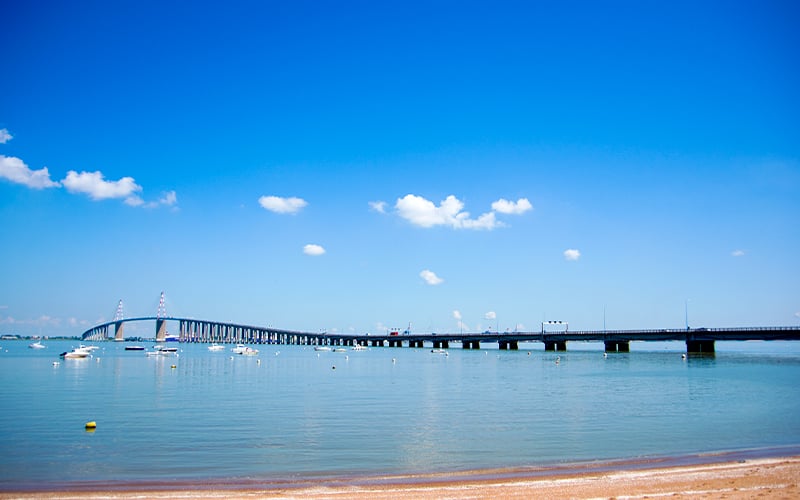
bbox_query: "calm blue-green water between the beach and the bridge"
[0,341,800,489]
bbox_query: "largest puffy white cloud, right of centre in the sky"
[395,194,503,230]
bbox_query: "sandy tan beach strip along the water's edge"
[0,456,800,500]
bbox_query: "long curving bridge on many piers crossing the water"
[81,316,800,353]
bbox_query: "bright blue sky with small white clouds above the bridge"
[0,0,800,335]
